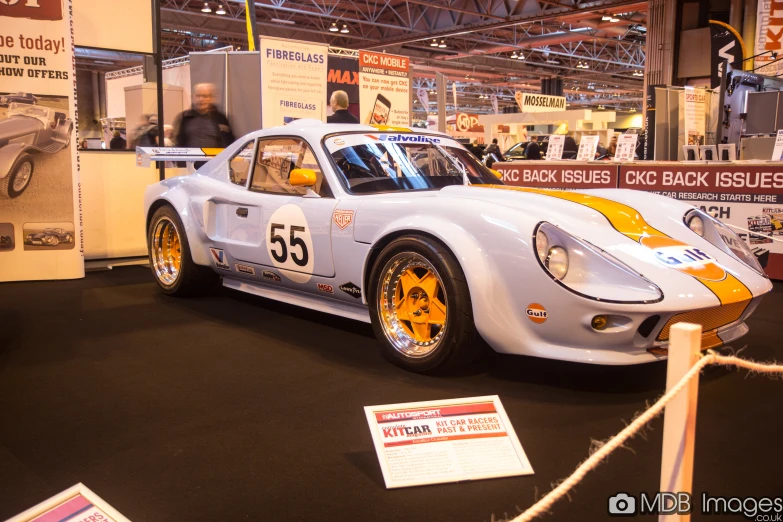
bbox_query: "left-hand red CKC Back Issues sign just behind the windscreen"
[492,162,617,190]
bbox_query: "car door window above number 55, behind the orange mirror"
[250,138,332,197]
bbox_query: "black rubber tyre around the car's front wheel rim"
[367,235,484,372]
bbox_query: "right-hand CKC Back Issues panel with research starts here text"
[619,163,783,279]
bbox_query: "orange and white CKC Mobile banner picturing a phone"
[359,51,410,126]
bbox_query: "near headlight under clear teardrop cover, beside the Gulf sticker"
[533,222,663,303]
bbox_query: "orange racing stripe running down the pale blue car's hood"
[472,185,753,305]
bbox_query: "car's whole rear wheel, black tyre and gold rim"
[147,205,218,296]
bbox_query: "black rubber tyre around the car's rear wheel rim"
[147,205,220,297]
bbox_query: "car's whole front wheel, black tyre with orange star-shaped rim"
[368,236,483,372]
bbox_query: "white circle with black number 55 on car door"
[266,205,314,283]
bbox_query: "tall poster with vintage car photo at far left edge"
[0,0,84,281]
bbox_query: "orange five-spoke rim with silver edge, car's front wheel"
[378,252,447,359]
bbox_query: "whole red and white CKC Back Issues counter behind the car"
[493,161,783,279]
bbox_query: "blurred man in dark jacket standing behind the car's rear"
[174,83,234,148]
